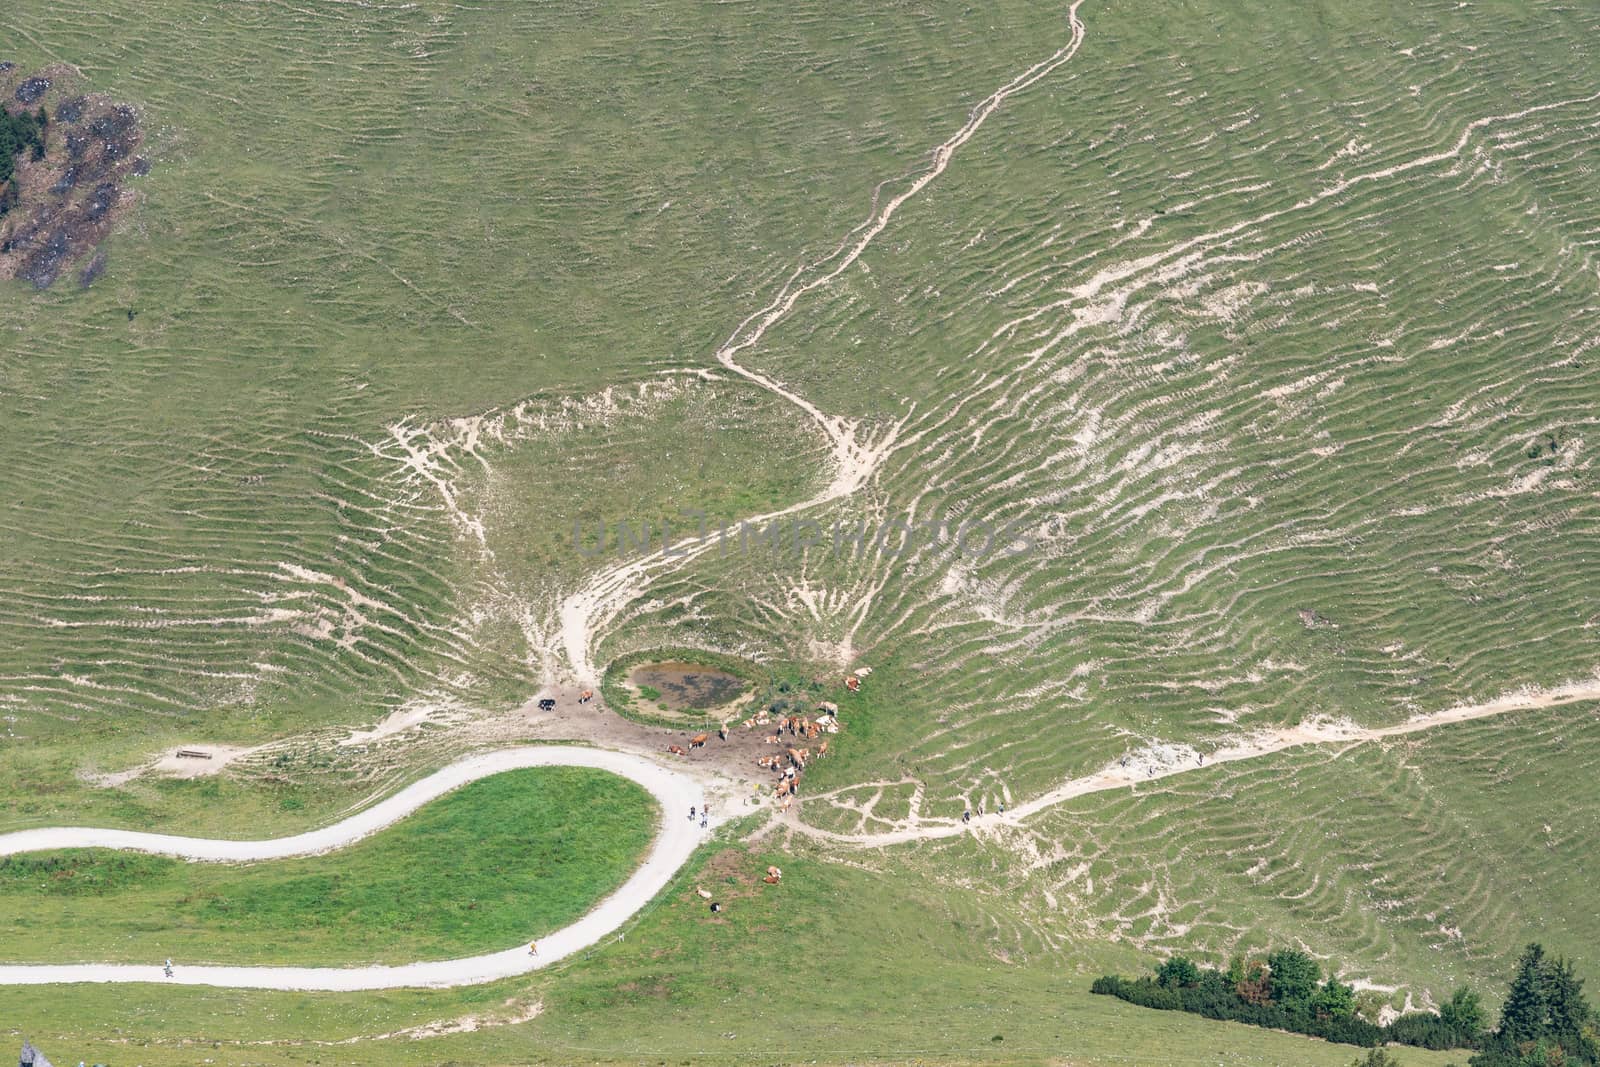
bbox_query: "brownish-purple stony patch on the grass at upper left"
[0,62,149,290]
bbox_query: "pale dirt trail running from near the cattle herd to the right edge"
[780,678,1600,848]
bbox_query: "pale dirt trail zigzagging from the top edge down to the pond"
[558,0,1085,685]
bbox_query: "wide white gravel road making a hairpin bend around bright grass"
[0,745,707,990]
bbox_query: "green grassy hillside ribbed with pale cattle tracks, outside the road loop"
[0,0,1600,1064]
